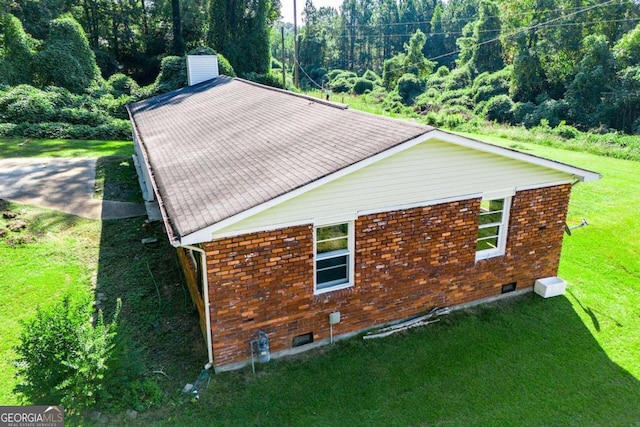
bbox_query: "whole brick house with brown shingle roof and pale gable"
[129,72,600,371]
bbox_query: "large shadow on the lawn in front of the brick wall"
[132,295,640,426]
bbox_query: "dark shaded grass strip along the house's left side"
[85,157,207,423]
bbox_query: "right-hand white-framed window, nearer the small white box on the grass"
[476,198,511,260]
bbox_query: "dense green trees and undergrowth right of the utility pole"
[288,0,640,133]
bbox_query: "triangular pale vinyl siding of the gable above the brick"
[214,140,572,236]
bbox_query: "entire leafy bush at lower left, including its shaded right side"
[15,297,164,414]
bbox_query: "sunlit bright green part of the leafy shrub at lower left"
[15,297,120,412]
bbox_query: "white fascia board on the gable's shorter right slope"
[431,130,602,182]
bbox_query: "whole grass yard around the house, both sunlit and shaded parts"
[0,137,640,426]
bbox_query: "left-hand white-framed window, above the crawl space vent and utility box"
[315,222,353,293]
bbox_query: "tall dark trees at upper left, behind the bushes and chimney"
[0,0,280,84]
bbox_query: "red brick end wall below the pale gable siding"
[205,184,571,366]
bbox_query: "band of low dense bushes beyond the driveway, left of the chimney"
[0,48,236,139]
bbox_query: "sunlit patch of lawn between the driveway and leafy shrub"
[0,206,100,405]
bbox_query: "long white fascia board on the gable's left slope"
[180,131,433,245]
